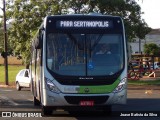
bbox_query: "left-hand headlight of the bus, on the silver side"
[45,78,60,93]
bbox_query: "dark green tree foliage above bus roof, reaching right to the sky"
[62,0,151,41]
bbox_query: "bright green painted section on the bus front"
[78,78,120,94]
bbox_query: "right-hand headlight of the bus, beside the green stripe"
[113,78,127,93]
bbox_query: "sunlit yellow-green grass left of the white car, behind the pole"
[0,65,25,85]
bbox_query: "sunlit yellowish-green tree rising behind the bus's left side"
[7,0,61,68]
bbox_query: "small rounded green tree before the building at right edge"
[144,43,160,55]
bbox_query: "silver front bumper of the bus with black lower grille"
[42,89,127,107]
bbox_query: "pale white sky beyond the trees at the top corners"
[0,0,160,29]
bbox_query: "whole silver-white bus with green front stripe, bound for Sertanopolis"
[31,14,127,114]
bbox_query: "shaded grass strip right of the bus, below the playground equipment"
[128,80,160,85]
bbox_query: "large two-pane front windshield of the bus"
[46,33,124,76]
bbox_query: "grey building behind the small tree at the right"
[130,29,160,54]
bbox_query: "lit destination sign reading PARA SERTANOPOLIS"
[57,20,113,28]
